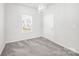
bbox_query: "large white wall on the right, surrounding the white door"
[43,3,79,52]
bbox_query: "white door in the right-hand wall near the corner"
[43,14,54,37]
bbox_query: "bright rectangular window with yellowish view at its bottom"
[22,15,32,32]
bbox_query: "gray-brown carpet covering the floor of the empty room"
[2,37,79,56]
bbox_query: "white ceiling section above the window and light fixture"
[20,3,52,9]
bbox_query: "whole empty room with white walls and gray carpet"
[0,3,79,56]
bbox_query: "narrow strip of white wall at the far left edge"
[0,3,5,54]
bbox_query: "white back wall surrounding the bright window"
[6,4,41,42]
